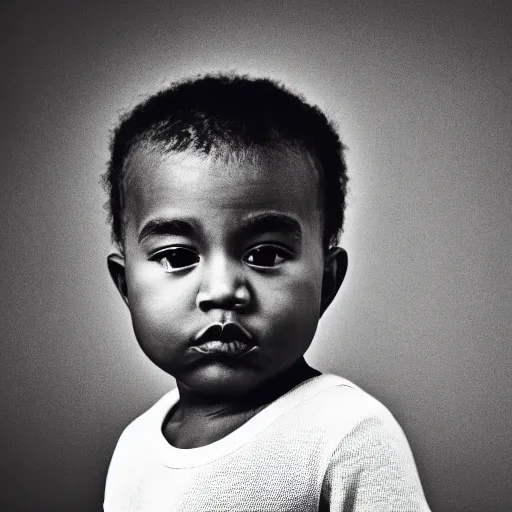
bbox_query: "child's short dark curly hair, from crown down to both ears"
[102,74,348,248]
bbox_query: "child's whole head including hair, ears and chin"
[106,76,347,396]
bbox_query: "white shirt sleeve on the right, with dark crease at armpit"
[320,407,430,512]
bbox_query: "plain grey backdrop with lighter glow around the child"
[0,0,512,512]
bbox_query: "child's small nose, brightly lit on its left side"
[196,257,251,312]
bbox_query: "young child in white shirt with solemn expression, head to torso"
[104,75,429,512]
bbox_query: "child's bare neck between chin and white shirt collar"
[163,358,320,448]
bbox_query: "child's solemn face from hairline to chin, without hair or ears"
[113,146,336,396]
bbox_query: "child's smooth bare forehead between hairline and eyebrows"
[124,146,320,208]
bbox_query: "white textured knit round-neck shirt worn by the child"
[104,375,429,512]
